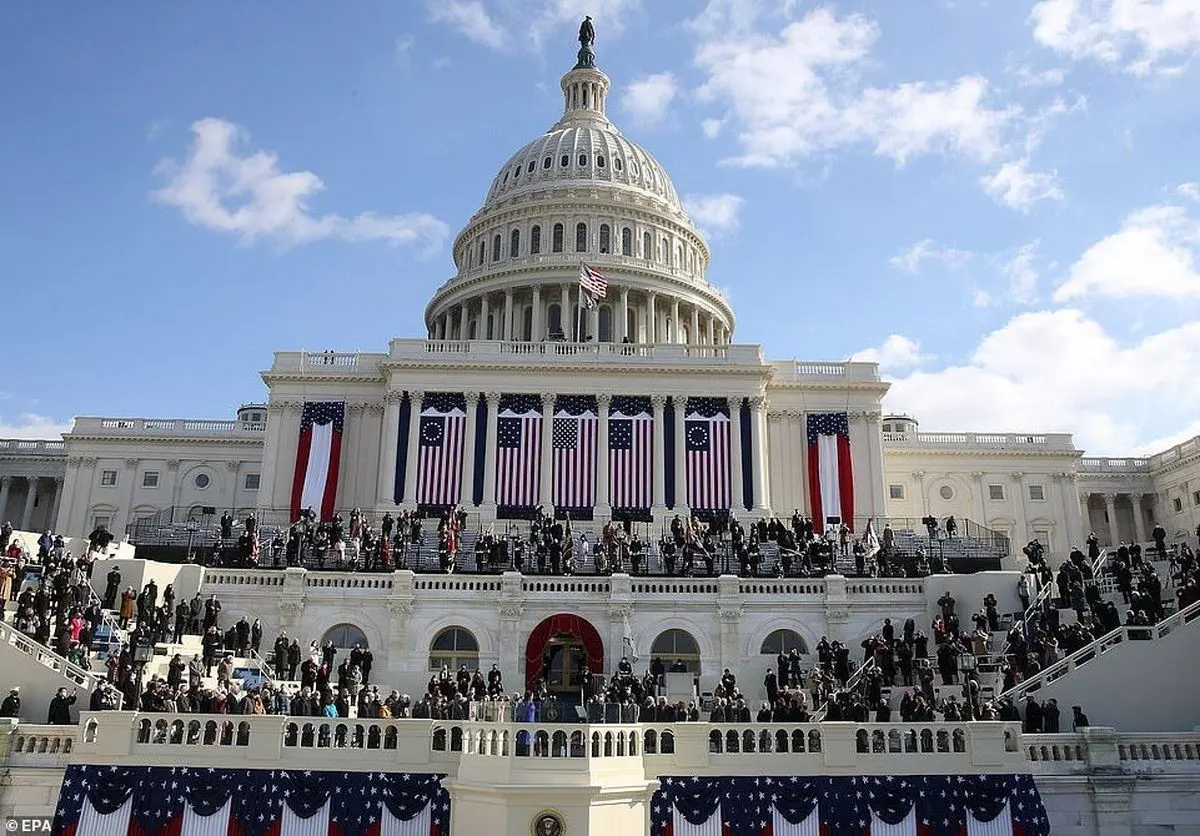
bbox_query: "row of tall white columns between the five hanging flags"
[377,391,770,516]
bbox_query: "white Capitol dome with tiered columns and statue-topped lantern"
[425,36,734,345]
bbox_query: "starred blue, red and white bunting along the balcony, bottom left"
[53,765,450,836]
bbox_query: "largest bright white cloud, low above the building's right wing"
[886,309,1200,455]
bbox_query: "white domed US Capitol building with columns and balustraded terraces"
[0,26,1200,836]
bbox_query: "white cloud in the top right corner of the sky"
[1030,0,1200,74]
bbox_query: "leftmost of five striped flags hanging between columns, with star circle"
[416,392,467,506]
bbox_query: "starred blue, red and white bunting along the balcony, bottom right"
[650,775,1050,836]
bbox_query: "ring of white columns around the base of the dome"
[430,282,731,345]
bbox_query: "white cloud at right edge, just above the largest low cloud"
[1055,205,1200,301]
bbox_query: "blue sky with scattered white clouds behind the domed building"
[0,0,1200,455]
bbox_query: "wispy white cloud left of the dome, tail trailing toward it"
[151,118,449,249]
